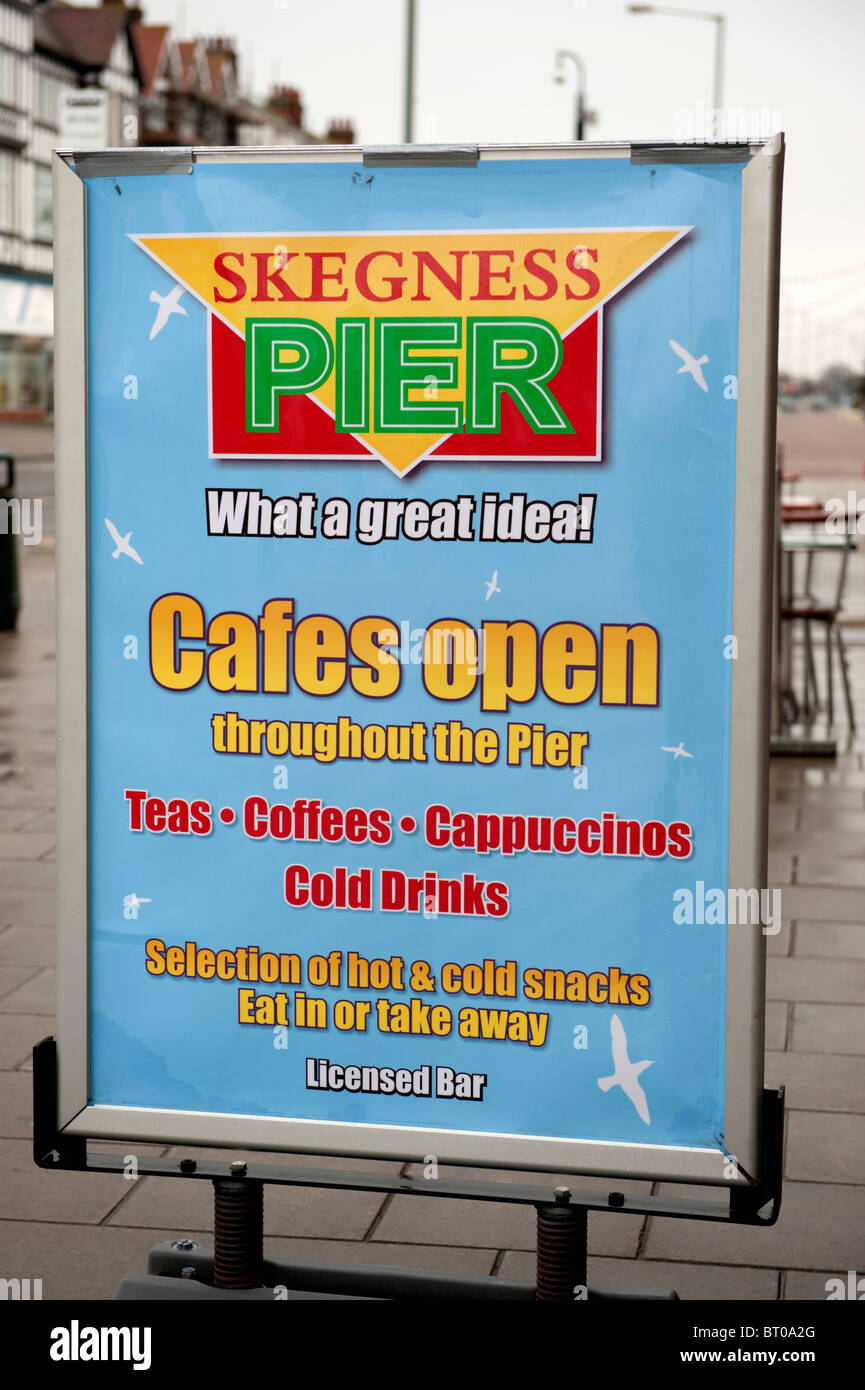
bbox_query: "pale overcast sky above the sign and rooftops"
[94,0,865,371]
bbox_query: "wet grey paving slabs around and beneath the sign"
[0,414,865,1301]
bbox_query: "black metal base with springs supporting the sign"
[33,1038,784,1302]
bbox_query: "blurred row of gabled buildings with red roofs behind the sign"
[0,0,353,420]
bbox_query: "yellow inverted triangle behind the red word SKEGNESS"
[132,227,690,474]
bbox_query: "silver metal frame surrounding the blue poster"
[54,136,783,1187]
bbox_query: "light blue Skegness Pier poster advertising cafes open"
[85,156,741,1156]
